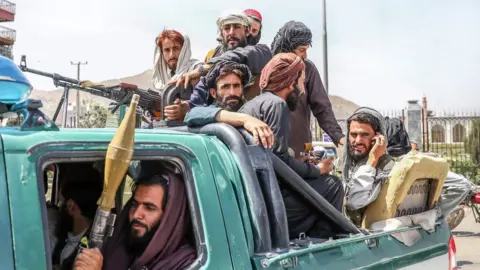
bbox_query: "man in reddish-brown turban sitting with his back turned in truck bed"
[239,53,344,238]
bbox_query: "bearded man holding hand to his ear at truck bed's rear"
[342,107,395,225]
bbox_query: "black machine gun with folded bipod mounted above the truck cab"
[19,55,163,127]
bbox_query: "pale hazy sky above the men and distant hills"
[7,0,480,111]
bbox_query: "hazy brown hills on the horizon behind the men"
[30,69,359,119]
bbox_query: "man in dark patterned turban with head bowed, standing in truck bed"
[271,21,345,158]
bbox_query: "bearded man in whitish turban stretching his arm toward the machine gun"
[169,11,272,120]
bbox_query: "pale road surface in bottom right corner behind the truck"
[453,209,480,270]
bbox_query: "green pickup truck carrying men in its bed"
[0,121,456,270]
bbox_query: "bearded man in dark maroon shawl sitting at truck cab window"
[73,174,197,270]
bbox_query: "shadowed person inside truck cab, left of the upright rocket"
[52,164,103,269]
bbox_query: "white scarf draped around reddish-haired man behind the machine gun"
[152,33,202,92]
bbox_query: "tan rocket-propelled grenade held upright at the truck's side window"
[88,94,140,249]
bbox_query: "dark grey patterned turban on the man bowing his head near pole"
[271,21,312,55]
